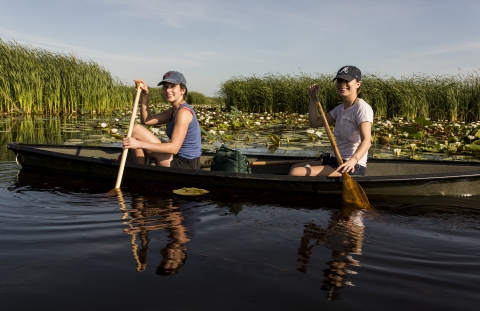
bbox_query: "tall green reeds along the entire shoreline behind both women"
[0,39,480,122]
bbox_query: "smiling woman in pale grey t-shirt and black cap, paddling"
[290,66,373,177]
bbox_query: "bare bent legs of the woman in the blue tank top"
[132,124,173,167]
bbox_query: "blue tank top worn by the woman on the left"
[165,103,202,159]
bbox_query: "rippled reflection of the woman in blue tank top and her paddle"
[118,192,199,275]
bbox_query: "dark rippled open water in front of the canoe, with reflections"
[0,161,480,310]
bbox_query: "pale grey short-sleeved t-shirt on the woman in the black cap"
[330,98,373,166]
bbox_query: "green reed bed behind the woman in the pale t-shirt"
[218,72,480,121]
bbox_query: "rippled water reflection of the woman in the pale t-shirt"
[297,206,365,300]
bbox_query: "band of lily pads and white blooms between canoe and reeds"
[0,103,480,165]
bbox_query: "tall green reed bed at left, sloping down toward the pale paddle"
[0,39,134,114]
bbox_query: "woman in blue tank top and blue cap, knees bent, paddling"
[123,71,202,169]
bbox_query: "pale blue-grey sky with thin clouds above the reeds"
[0,0,480,96]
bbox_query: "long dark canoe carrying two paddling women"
[7,142,480,196]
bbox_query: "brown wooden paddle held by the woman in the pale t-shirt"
[317,102,370,208]
